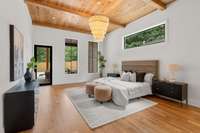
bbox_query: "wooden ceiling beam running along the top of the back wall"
[32,21,91,34]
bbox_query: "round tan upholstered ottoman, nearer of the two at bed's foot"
[94,85,112,103]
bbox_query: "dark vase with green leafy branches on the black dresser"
[24,57,37,82]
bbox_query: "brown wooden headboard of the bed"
[122,60,159,79]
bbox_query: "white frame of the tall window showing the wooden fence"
[64,39,79,75]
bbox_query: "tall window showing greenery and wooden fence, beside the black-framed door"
[65,39,78,74]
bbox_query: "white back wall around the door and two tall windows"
[33,26,99,84]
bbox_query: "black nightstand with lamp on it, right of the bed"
[152,81,188,104]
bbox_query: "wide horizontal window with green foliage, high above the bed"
[124,24,166,49]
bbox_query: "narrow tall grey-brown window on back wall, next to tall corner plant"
[88,42,98,73]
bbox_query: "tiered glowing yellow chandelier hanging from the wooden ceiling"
[89,15,109,42]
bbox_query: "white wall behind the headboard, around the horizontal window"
[103,0,200,106]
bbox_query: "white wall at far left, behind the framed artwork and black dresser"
[0,0,32,133]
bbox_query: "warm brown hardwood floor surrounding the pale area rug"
[23,84,200,133]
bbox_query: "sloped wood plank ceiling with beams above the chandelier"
[26,0,174,34]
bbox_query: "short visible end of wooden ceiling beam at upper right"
[143,0,167,11]
